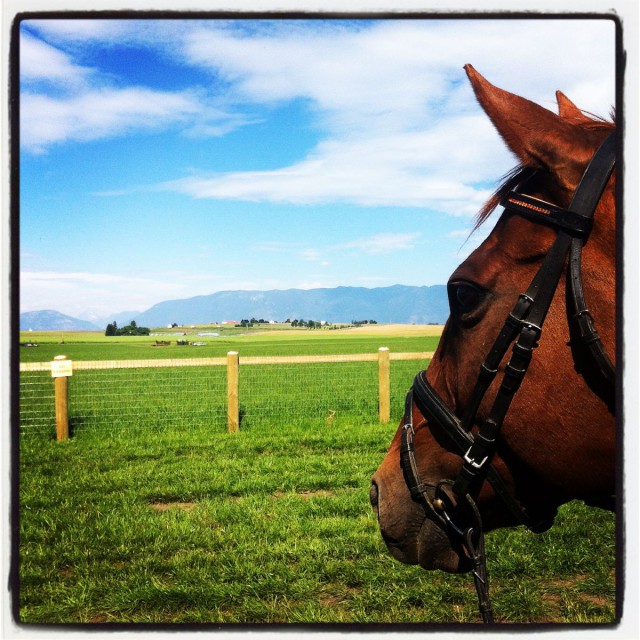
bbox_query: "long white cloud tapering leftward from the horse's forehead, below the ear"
[160,115,498,216]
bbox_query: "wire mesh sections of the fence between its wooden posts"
[19,354,426,436]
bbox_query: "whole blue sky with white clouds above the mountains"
[20,19,615,318]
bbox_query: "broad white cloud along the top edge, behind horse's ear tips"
[183,20,615,130]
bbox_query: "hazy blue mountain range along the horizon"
[20,285,449,331]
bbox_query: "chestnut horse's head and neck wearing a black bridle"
[371,65,616,621]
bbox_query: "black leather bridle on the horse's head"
[400,132,616,623]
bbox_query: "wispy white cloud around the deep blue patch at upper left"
[20,20,259,154]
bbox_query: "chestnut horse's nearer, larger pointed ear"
[465,64,593,189]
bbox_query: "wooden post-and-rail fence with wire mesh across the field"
[20,347,433,440]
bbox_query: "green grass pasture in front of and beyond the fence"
[16,327,616,625]
